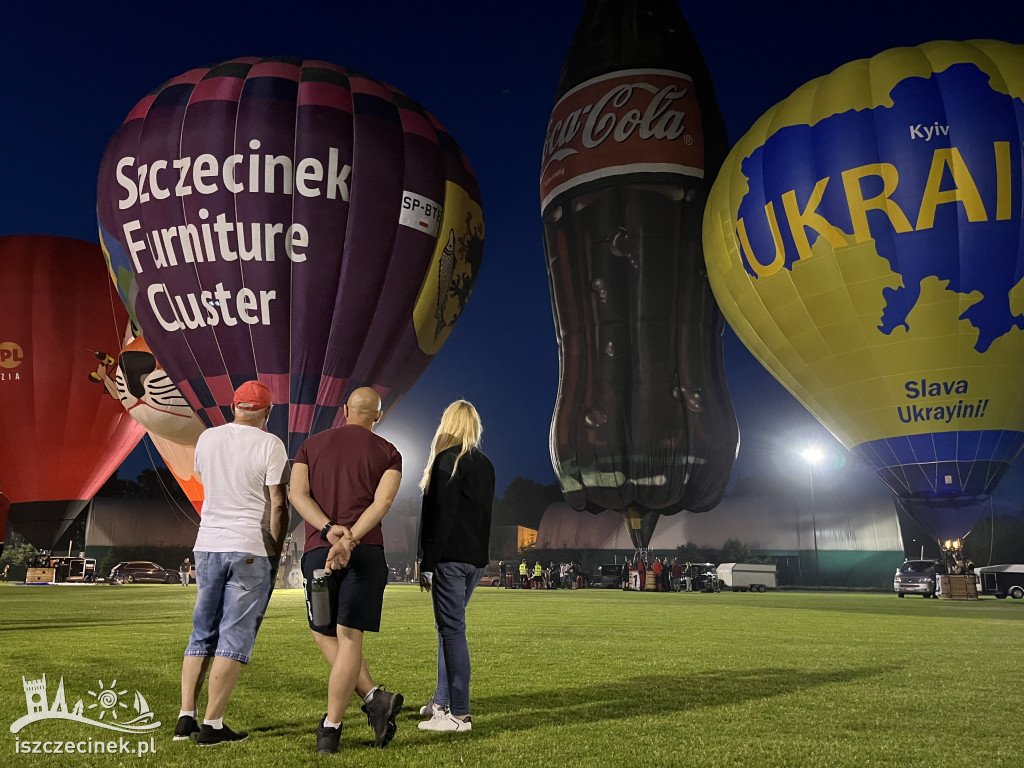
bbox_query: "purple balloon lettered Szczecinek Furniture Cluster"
[97,58,483,456]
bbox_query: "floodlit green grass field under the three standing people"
[0,586,1024,768]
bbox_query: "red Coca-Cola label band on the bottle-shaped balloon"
[541,70,703,211]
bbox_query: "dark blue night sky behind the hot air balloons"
[0,0,1024,506]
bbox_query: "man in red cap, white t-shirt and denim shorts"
[174,381,288,746]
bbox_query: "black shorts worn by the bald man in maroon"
[302,544,388,637]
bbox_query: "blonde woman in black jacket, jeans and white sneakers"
[420,400,495,731]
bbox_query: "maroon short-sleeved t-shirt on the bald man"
[295,424,401,552]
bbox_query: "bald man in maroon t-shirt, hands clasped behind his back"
[289,387,404,755]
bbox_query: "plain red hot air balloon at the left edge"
[0,236,142,548]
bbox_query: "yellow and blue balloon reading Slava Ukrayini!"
[703,40,1024,539]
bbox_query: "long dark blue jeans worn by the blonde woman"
[430,562,483,716]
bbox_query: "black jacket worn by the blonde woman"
[420,445,495,571]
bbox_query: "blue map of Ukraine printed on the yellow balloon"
[739,63,1024,352]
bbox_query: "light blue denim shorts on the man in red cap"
[185,552,278,664]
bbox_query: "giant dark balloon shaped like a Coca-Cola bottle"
[541,0,738,547]
